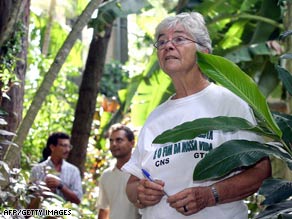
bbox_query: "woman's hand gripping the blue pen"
[137,179,164,208]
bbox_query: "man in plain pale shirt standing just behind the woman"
[97,124,140,219]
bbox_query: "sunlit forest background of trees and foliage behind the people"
[0,0,292,218]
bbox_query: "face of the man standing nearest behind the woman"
[109,130,134,159]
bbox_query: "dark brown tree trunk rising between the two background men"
[68,26,112,176]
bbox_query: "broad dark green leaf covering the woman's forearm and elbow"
[193,140,292,180]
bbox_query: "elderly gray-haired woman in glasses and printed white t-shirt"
[123,12,271,219]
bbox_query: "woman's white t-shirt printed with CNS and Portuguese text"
[122,83,261,219]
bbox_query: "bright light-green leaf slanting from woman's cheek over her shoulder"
[197,52,282,137]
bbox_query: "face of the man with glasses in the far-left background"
[50,139,72,159]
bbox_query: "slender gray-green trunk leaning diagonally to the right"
[4,0,100,167]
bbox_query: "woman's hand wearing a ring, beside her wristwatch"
[167,187,214,215]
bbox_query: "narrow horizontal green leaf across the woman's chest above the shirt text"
[153,116,277,144]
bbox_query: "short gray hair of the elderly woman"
[155,12,212,53]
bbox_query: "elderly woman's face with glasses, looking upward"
[157,26,196,76]
